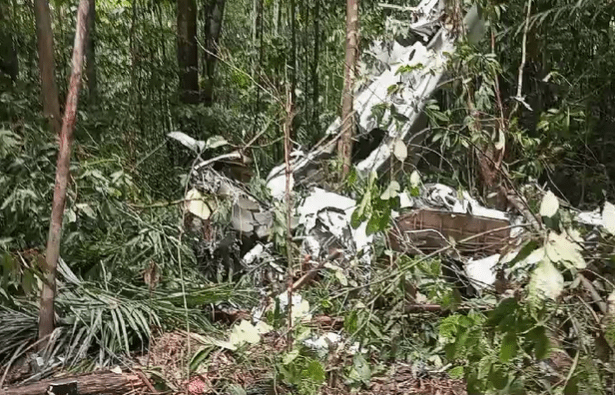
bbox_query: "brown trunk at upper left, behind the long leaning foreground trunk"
[34,0,62,134]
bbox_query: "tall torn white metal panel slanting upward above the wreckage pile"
[267,0,462,198]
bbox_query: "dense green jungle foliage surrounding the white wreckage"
[0,0,615,394]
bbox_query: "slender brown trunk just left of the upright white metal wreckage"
[338,0,359,179]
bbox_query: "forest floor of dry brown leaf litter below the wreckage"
[144,333,467,395]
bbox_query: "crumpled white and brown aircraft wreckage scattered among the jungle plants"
[169,0,608,296]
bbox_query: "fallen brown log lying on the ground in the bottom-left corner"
[0,372,151,395]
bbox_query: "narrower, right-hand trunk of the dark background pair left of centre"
[203,0,226,106]
